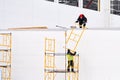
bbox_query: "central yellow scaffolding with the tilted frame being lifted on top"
[44,28,86,80]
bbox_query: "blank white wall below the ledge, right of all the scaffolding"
[78,30,120,80]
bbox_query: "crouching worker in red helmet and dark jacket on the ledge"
[76,14,87,28]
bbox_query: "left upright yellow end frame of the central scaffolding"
[44,38,55,80]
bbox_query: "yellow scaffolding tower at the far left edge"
[0,33,12,80]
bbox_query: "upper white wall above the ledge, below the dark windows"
[0,0,120,29]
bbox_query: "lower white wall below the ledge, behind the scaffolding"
[0,30,120,80]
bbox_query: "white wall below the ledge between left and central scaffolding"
[12,31,65,80]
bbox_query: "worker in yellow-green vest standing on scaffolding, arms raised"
[67,49,76,72]
